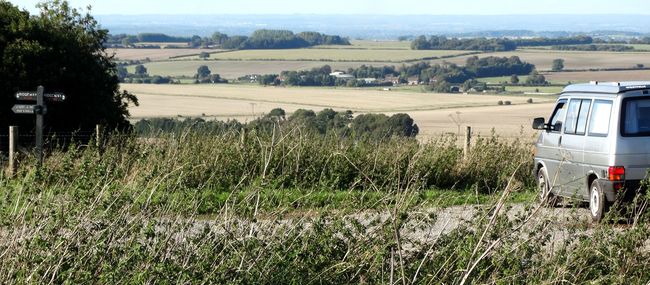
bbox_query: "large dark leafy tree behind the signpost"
[0,0,137,138]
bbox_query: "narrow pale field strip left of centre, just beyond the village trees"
[129,60,398,79]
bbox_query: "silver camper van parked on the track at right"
[533,82,650,221]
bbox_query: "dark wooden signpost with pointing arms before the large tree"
[11,86,65,167]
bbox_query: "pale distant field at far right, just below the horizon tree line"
[432,50,650,71]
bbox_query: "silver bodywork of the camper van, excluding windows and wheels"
[535,82,650,200]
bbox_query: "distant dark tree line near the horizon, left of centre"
[106,29,350,49]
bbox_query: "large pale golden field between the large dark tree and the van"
[122,84,555,138]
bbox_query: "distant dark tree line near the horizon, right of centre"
[411,36,593,51]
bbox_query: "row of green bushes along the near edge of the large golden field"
[134,108,419,140]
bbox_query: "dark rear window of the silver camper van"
[622,97,650,136]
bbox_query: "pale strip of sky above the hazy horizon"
[9,0,650,15]
